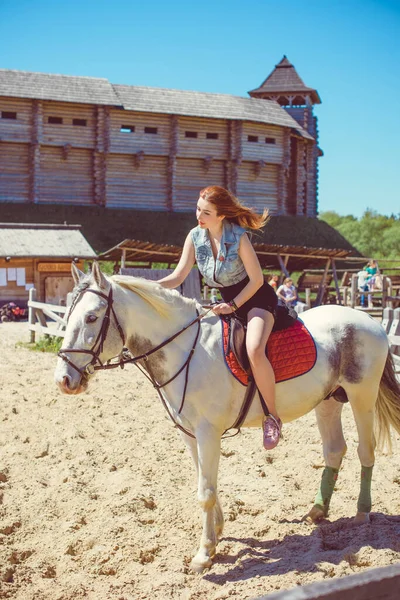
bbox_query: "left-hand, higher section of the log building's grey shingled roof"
[0,69,121,106]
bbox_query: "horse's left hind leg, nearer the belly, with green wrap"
[305,398,347,523]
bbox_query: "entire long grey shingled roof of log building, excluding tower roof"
[0,69,313,140]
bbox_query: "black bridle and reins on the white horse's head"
[58,287,206,438]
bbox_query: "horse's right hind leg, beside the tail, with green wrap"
[348,382,378,523]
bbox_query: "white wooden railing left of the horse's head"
[28,288,68,343]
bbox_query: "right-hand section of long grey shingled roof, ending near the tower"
[113,85,313,139]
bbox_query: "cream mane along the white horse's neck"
[110,275,196,318]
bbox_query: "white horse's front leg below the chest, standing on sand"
[190,426,222,573]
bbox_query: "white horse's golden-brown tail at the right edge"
[376,351,400,450]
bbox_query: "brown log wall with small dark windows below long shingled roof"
[0,98,318,216]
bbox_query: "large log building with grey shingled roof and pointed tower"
[0,57,321,218]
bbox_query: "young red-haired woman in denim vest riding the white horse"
[159,185,282,450]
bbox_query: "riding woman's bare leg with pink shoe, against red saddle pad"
[246,308,281,450]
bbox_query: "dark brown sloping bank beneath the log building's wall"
[1,202,361,256]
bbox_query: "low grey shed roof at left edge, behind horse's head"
[0,223,96,259]
